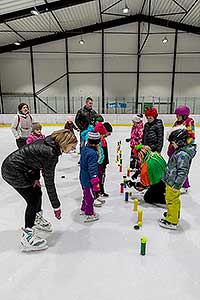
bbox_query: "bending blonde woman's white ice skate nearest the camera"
[21,228,48,252]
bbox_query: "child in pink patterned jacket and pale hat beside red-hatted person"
[126,114,144,169]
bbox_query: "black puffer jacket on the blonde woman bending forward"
[1,136,61,208]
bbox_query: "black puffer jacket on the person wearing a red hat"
[142,119,164,153]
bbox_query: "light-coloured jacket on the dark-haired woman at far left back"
[11,112,33,139]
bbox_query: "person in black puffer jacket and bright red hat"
[142,107,164,153]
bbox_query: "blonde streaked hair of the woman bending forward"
[51,129,78,150]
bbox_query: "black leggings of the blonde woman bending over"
[15,186,42,228]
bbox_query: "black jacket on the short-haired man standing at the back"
[75,106,97,131]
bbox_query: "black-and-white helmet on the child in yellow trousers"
[168,126,188,147]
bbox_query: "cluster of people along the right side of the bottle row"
[127,105,196,229]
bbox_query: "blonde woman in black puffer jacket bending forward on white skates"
[1,129,77,251]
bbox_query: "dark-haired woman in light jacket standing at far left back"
[11,103,33,149]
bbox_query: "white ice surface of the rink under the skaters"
[0,127,200,300]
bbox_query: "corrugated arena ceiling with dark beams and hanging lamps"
[0,0,200,53]
